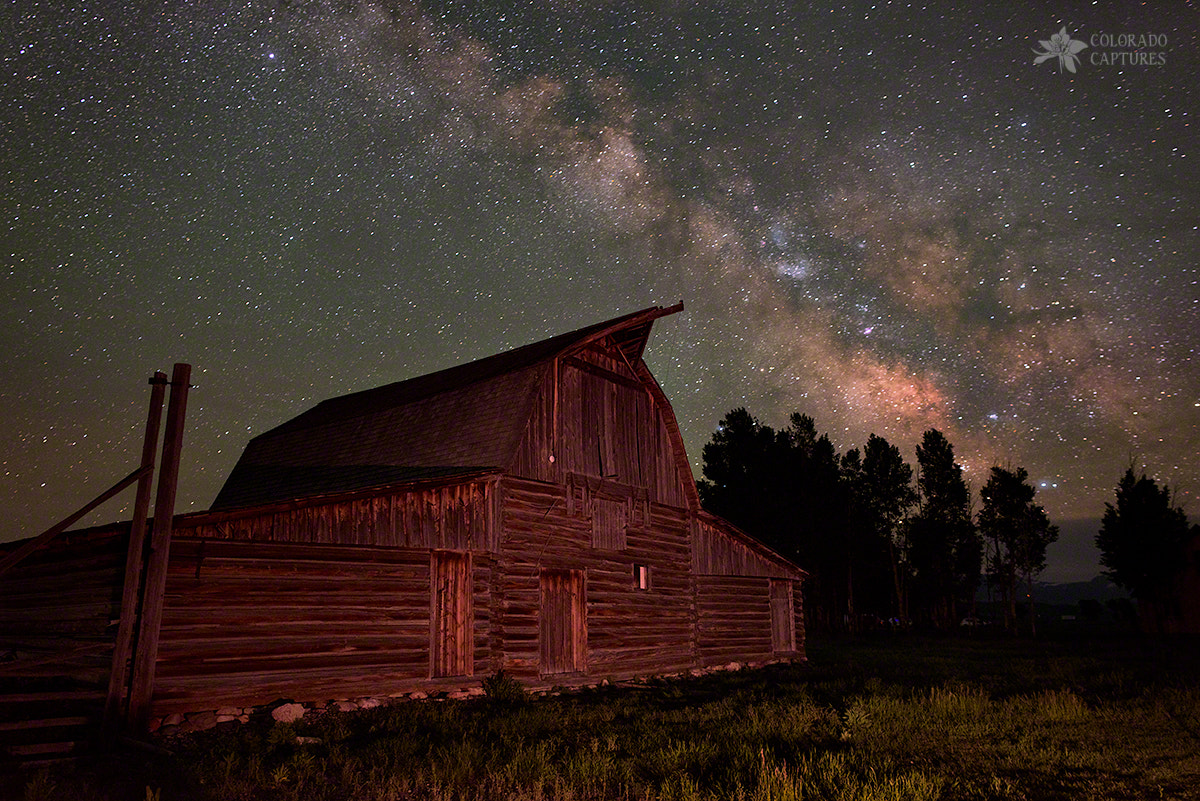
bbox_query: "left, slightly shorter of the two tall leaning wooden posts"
[104,371,167,735]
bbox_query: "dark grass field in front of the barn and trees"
[12,637,1200,801]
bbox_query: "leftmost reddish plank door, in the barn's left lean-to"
[430,550,474,677]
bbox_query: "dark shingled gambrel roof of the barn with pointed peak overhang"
[212,303,683,510]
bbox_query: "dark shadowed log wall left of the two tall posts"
[0,525,128,686]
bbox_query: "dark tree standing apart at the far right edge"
[1096,468,1188,628]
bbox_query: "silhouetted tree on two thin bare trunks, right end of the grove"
[979,466,1058,634]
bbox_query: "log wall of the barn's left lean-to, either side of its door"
[152,536,494,715]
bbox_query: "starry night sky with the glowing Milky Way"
[0,0,1200,578]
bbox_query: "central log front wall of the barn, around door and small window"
[496,478,696,683]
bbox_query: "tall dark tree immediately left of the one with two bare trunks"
[908,428,983,627]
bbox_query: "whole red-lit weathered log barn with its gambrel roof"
[0,303,805,748]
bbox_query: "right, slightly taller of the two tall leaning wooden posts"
[128,363,192,731]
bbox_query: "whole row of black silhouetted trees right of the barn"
[697,408,1195,631]
